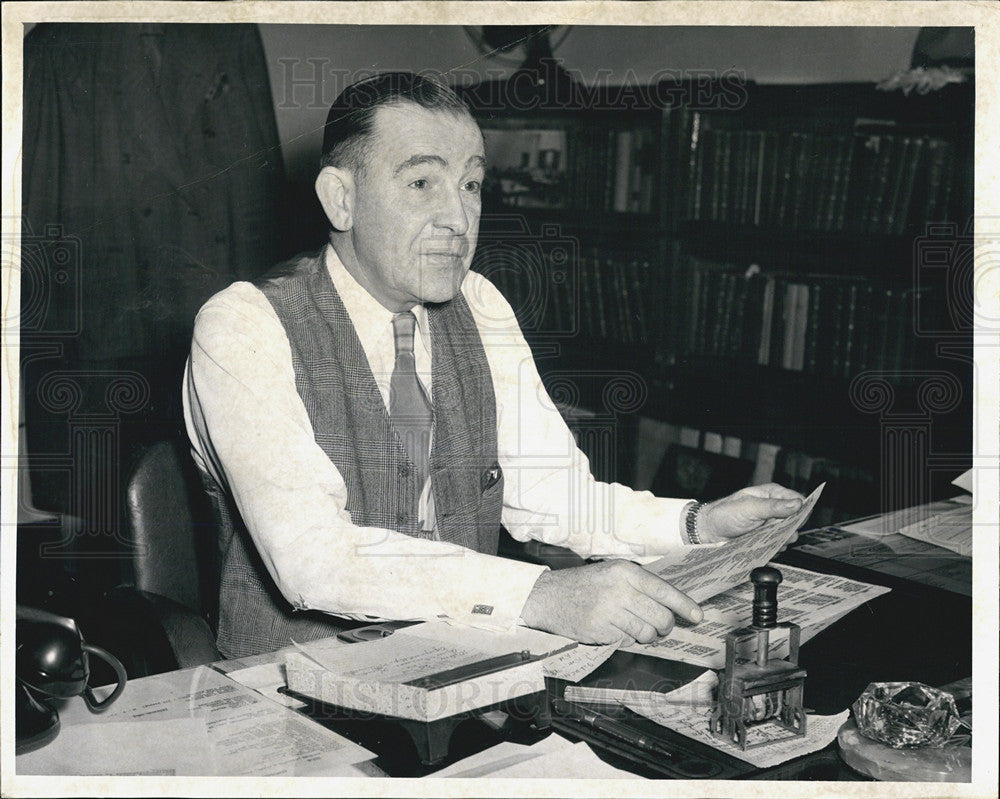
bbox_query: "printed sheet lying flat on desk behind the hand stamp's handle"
[626,565,889,669]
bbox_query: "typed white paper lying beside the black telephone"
[16,666,375,776]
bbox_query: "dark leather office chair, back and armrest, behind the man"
[101,441,221,677]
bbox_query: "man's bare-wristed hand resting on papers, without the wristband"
[521,560,704,645]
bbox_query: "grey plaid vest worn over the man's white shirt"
[209,252,504,657]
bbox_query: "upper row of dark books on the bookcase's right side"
[682,112,955,234]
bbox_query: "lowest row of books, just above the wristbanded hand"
[631,417,879,527]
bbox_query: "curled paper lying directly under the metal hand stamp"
[627,702,848,768]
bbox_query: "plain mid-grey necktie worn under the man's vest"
[389,311,434,488]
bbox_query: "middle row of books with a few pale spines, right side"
[678,258,931,377]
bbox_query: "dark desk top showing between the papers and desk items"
[17,532,972,780]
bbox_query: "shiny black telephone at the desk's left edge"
[15,605,127,755]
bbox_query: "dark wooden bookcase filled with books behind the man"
[458,79,974,513]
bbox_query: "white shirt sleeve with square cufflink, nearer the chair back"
[184,283,544,629]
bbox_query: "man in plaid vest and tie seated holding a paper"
[185,73,801,657]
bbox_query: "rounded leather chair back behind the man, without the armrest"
[125,441,218,631]
